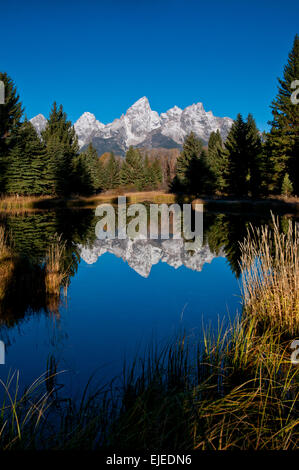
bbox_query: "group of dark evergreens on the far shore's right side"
[171,35,299,197]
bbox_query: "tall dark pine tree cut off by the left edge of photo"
[0,73,23,193]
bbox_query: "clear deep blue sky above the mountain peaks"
[0,0,299,130]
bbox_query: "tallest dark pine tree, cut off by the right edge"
[266,34,299,194]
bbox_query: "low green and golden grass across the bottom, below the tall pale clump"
[0,317,299,452]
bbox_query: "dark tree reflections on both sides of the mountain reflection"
[0,207,296,327]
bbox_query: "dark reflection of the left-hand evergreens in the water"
[0,210,95,326]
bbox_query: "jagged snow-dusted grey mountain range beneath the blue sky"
[31,97,233,155]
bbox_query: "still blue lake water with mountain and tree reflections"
[0,209,292,397]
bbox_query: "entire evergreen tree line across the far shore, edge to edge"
[0,35,299,197]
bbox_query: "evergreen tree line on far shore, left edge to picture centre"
[0,87,162,196]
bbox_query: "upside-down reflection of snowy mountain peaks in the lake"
[78,239,224,277]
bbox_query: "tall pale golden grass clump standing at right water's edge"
[241,216,299,337]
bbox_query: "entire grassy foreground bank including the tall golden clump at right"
[0,215,299,452]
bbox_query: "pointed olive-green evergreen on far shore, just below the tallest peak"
[120,146,145,191]
